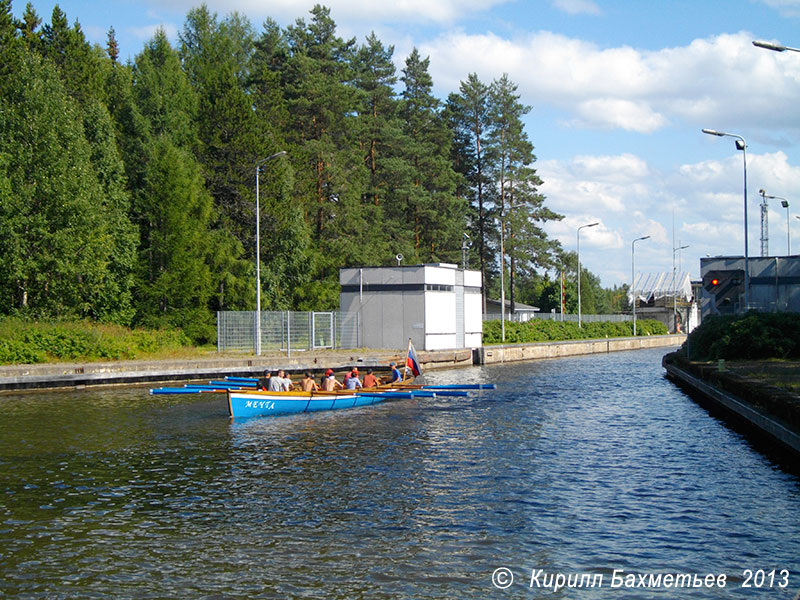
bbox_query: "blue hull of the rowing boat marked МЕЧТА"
[228,390,392,419]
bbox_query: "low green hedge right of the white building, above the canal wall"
[483,319,668,344]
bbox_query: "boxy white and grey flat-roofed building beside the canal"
[339,263,483,350]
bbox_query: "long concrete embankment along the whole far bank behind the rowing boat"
[0,335,685,392]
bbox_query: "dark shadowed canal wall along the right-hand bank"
[662,352,800,455]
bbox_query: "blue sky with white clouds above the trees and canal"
[13,0,800,286]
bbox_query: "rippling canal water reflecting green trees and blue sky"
[0,350,800,600]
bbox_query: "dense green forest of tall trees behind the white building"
[0,0,624,342]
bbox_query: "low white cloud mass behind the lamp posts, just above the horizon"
[538,151,800,286]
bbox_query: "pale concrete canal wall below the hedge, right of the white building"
[475,335,686,365]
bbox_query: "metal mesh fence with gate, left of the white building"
[217,310,360,353]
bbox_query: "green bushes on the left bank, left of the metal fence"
[0,318,199,364]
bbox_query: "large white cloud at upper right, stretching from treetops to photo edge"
[420,31,800,139]
